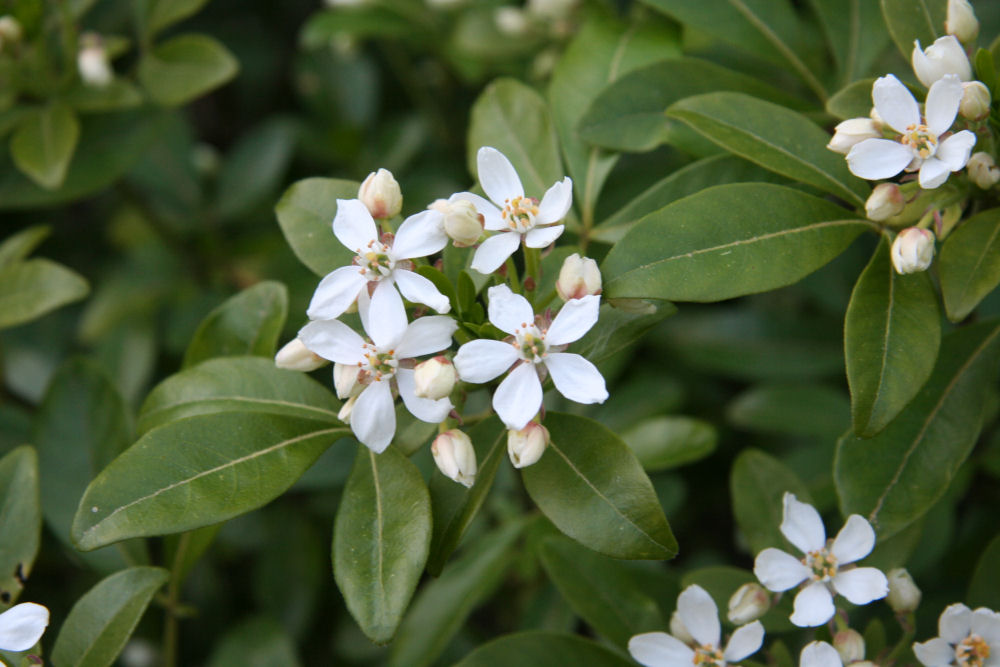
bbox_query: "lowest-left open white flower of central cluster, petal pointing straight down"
[299,292,458,453]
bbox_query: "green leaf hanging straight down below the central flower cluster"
[333,445,431,644]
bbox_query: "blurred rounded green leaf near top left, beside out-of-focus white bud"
[138,34,239,106]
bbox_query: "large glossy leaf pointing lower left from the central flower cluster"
[71,412,347,551]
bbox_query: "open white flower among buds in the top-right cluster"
[847,74,976,190]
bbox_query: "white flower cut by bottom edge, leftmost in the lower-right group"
[628,584,764,667]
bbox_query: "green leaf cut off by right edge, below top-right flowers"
[937,208,1000,322]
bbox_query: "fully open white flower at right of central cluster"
[455,285,608,430]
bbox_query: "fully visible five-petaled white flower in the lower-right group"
[753,493,889,627]
